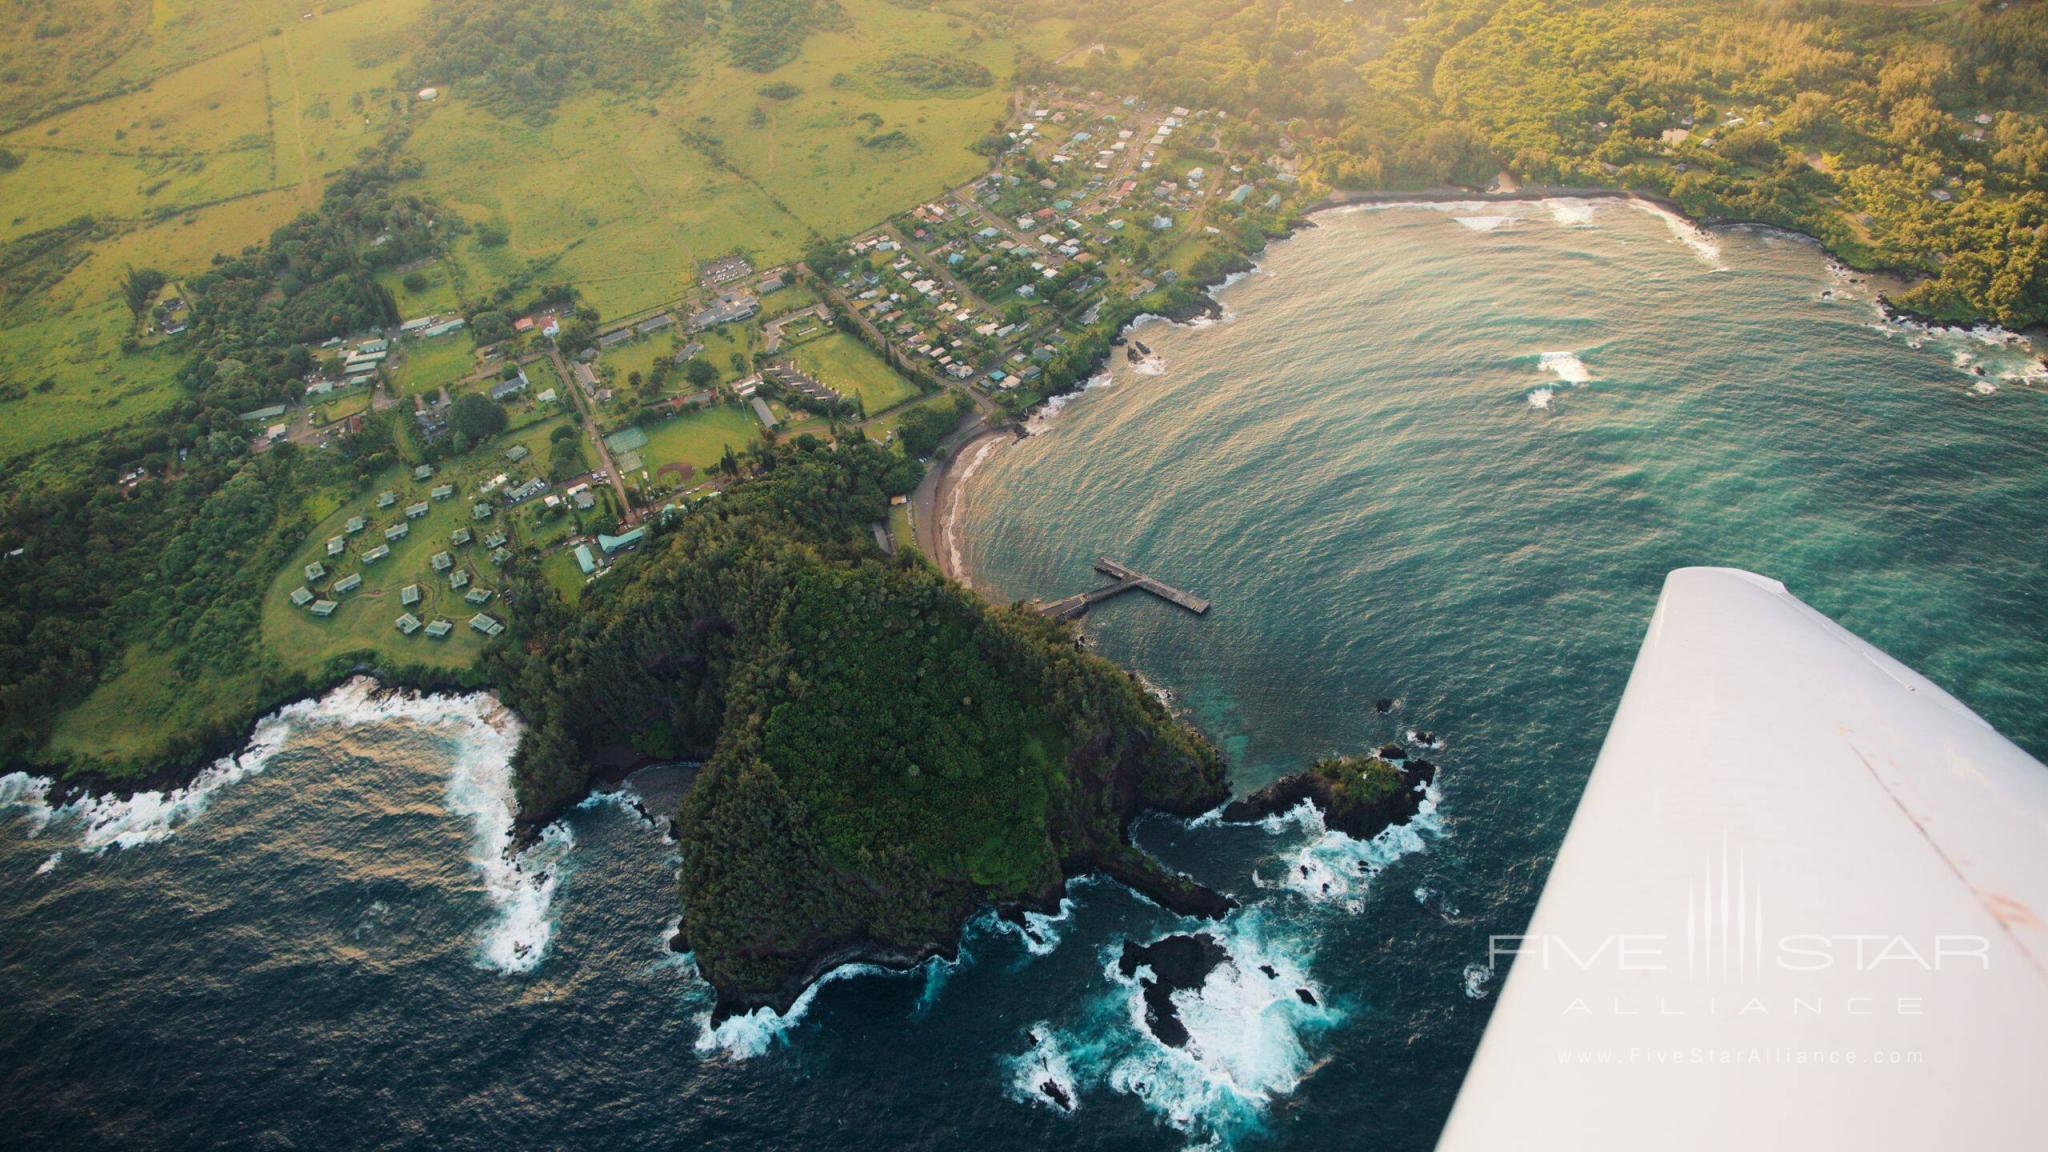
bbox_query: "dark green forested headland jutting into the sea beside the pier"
[489,443,1227,1006]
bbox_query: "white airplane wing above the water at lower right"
[1438,568,2048,1152]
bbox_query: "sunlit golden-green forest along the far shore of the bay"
[1019,0,2048,326]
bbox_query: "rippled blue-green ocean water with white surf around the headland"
[0,203,2048,1150]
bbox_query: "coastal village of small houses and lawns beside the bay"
[244,86,1296,647]
